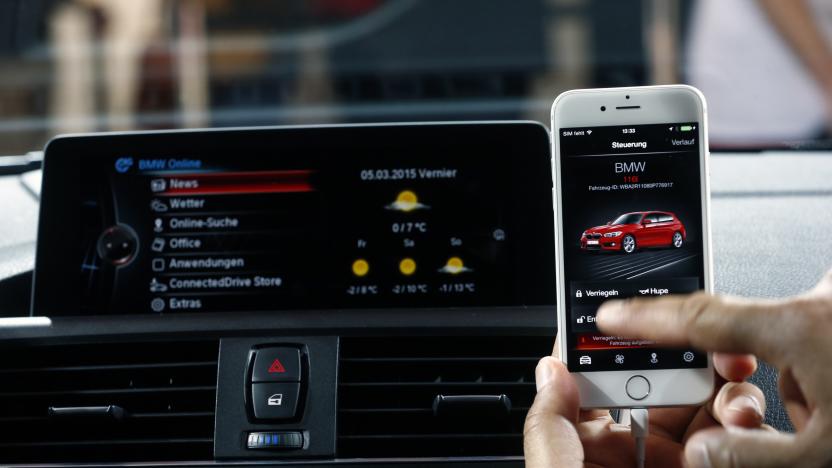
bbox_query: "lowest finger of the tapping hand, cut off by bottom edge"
[684,428,806,468]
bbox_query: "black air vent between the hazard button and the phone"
[338,337,554,458]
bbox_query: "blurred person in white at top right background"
[686,0,832,147]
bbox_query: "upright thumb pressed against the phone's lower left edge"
[523,357,584,468]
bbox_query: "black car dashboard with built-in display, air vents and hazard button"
[0,123,832,466]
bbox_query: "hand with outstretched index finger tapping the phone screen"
[596,270,832,467]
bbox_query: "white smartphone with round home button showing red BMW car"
[552,85,714,408]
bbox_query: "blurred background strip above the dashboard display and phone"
[0,0,832,155]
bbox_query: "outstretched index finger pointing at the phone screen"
[597,292,795,362]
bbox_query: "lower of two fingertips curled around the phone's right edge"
[706,382,766,429]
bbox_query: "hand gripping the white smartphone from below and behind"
[523,345,765,467]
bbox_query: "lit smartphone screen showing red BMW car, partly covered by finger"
[559,122,707,372]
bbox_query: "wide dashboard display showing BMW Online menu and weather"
[34,123,554,315]
